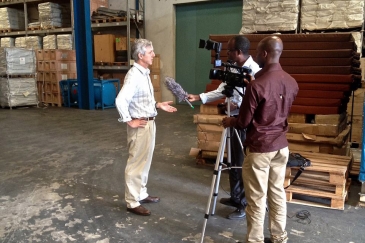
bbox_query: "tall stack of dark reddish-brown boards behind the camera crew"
[209,33,361,115]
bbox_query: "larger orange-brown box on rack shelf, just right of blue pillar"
[94,34,115,62]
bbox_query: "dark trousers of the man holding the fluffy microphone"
[229,128,246,207]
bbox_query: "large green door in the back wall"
[176,0,243,100]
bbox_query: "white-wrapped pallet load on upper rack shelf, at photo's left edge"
[0,7,25,30]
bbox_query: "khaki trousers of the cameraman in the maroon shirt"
[242,147,289,243]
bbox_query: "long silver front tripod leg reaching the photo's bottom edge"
[200,129,227,243]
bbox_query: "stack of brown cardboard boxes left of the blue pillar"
[36,49,77,107]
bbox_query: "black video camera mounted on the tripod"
[199,39,252,97]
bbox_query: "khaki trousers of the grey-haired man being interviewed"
[125,121,156,208]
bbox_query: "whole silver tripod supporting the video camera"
[200,96,243,243]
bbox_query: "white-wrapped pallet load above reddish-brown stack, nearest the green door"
[240,0,299,34]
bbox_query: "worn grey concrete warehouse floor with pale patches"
[0,105,365,243]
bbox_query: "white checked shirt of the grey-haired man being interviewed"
[115,62,157,122]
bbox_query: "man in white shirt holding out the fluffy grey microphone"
[188,35,260,219]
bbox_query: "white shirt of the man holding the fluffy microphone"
[199,56,261,116]
